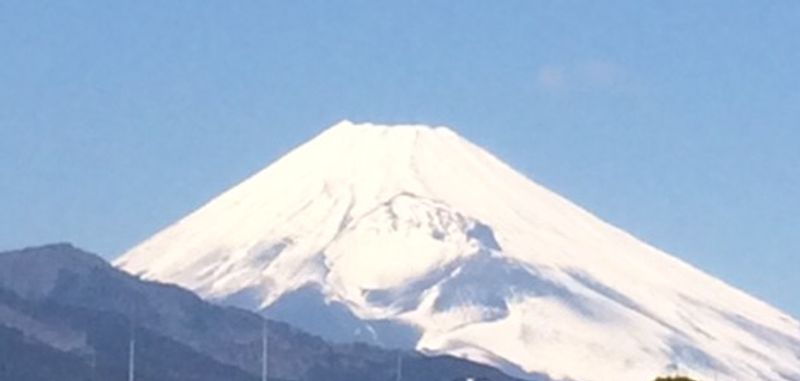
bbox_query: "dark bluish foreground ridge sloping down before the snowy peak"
[0,244,532,381]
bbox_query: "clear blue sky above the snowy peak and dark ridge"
[0,0,800,316]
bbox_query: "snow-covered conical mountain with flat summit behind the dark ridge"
[115,121,800,381]
